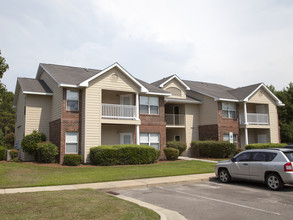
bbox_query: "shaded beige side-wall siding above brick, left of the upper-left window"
[40,72,63,121]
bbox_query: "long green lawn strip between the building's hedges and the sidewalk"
[0,161,215,188]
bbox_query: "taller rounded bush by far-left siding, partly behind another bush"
[21,131,46,159]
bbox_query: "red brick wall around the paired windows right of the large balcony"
[139,97,166,159]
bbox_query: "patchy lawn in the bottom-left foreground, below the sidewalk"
[0,189,160,220]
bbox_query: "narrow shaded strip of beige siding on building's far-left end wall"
[15,90,25,150]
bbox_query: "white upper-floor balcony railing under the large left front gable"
[102,104,137,120]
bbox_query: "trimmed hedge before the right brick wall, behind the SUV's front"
[191,141,236,158]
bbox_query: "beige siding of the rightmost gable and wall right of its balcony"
[248,88,279,143]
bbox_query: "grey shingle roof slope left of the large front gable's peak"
[40,63,101,85]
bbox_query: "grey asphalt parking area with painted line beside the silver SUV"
[115,180,293,220]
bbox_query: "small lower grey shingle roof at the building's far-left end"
[18,78,53,94]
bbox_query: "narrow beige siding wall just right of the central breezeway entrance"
[184,104,199,156]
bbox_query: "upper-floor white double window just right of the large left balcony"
[139,96,159,115]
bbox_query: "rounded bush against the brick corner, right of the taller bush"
[37,142,59,163]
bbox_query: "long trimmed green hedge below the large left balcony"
[90,144,160,166]
